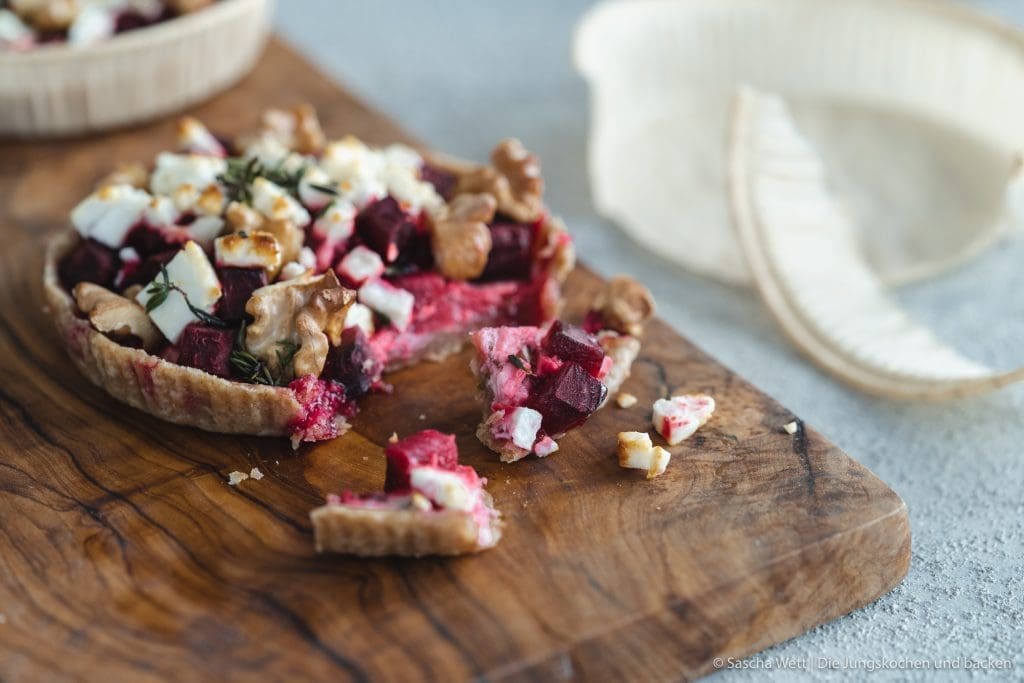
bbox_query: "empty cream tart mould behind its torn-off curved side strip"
[575,0,1024,285]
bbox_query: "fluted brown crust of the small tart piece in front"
[309,492,502,557]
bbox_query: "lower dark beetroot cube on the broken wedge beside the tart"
[526,362,608,436]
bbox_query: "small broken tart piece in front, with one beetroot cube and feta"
[309,429,502,556]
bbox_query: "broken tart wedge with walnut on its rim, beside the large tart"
[471,279,653,462]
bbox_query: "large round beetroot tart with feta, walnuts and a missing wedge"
[44,106,574,444]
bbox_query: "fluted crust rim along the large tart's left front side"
[43,232,301,436]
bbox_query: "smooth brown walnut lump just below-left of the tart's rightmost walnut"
[431,195,498,280]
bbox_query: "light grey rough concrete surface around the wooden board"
[278,0,1024,681]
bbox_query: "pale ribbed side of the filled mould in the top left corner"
[0,0,273,137]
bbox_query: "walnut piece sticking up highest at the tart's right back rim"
[455,138,544,223]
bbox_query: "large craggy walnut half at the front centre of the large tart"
[246,270,354,377]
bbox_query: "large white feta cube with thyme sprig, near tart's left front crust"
[135,241,221,344]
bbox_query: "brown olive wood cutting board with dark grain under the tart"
[0,41,910,682]
